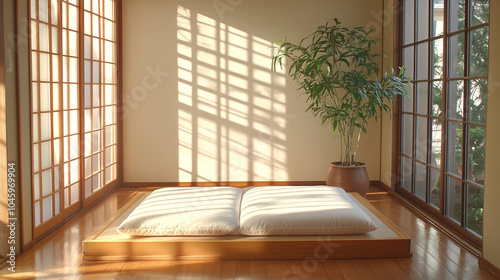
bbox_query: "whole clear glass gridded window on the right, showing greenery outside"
[398,0,489,244]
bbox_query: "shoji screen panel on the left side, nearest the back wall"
[83,0,117,201]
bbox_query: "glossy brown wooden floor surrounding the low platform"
[0,188,496,280]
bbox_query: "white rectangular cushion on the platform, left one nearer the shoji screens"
[117,187,242,236]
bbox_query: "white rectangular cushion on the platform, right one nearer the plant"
[239,186,376,236]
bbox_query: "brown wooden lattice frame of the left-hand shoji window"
[28,0,123,239]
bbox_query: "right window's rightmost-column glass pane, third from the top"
[468,79,488,123]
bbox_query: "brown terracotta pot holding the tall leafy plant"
[326,162,370,196]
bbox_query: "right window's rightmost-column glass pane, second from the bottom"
[467,125,486,185]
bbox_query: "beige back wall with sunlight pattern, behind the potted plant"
[123,0,382,182]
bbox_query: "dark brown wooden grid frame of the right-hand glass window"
[392,0,489,249]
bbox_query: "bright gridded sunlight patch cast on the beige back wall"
[177,6,291,182]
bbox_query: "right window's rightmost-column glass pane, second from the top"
[469,27,489,76]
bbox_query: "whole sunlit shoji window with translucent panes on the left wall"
[30,0,117,237]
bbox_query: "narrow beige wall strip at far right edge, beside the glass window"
[483,1,500,268]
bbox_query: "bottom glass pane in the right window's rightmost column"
[466,185,484,235]
